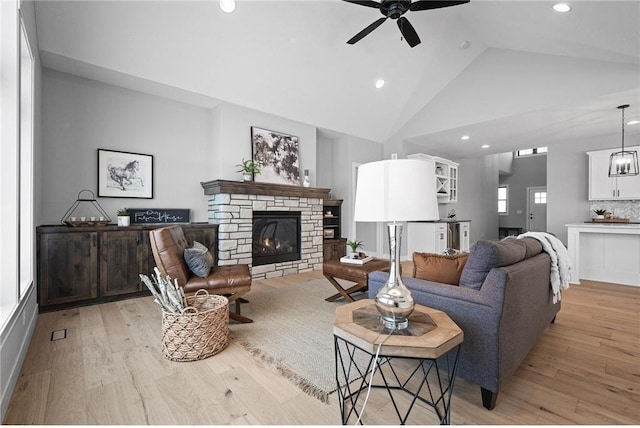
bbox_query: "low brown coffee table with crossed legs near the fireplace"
[322,259,389,302]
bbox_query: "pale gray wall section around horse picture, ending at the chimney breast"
[40,69,217,224]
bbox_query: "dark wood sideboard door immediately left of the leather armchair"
[100,230,150,296]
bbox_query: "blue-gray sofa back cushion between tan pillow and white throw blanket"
[460,239,527,290]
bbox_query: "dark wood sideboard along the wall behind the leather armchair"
[36,223,218,311]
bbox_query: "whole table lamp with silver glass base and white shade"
[354,155,440,330]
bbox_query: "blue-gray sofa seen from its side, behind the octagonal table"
[369,238,560,410]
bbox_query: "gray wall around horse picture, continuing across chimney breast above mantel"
[36,69,317,224]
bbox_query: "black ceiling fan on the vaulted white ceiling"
[344,0,470,47]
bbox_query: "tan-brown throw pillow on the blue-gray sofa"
[413,253,469,285]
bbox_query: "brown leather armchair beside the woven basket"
[149,225,253,323]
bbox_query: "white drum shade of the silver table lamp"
[354,159,440,222]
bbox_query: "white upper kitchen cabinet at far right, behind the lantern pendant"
[587,146,640,201]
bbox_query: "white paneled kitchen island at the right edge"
[566,222,640,286]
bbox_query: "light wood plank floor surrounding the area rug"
[3,272,640,425]
